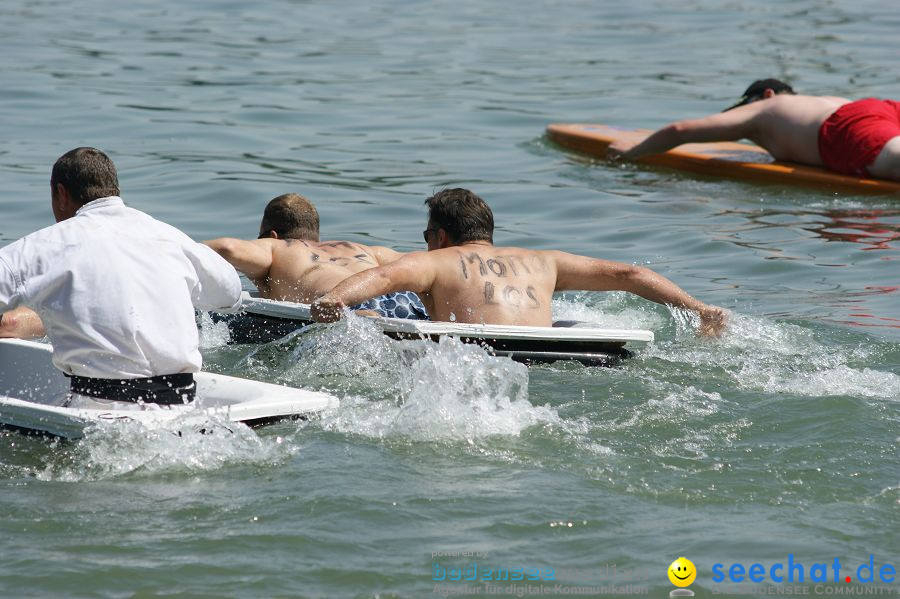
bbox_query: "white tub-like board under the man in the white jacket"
[0,339,338,439]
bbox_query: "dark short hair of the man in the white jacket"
[50,148,119,206]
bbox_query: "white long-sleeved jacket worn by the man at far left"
[0,196,241,379]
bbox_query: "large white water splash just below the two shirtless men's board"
[311,319,558,442]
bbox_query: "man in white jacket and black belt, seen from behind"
[0,148,241,409]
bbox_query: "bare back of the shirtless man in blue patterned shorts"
[264,239,379,303]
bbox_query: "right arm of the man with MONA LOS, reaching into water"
[550,252,727,335]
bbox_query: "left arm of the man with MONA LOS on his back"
[310,252,435,322]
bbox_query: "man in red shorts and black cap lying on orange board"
[608,79,900,181]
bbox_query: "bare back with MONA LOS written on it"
[423,243,556,326]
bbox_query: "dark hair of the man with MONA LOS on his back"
[425,188,494,243]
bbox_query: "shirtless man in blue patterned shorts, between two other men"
[203,193,428,320]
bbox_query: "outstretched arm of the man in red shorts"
[607,102,765,160]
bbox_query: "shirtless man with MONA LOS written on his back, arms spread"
[312,189,726,334]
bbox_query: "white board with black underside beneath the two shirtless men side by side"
[220,291,653,364]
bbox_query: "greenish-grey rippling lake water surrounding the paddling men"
[0,0,900,598]
